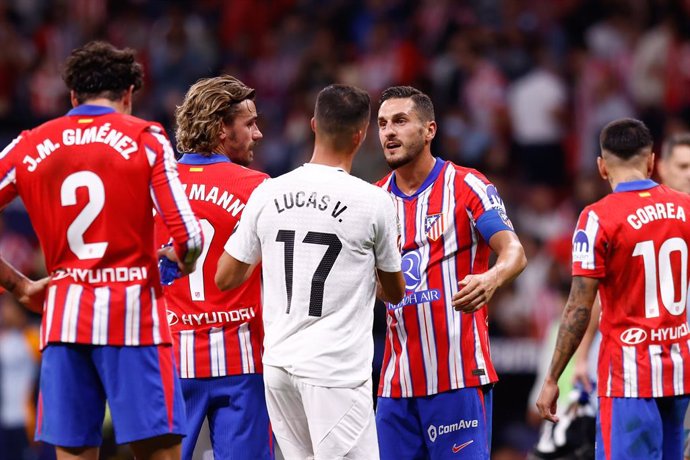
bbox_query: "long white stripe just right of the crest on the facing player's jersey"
[441,168,465,389]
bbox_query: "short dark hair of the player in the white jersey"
[314,85,371,149]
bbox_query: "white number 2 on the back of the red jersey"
[60,171,108,260]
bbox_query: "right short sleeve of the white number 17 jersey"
[374,189,401,272]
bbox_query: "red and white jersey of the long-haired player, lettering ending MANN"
[156,153,268,378]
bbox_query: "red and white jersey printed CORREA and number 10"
[573,180,690,398]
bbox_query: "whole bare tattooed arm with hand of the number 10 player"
[537,276,599,422]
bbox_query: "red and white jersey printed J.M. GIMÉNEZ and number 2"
[0,105,203,347]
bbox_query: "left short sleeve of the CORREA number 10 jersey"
[572,207,608,278]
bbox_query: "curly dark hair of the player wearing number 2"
[62,41,144,104]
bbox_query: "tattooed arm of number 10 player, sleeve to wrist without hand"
[549,276,599,380]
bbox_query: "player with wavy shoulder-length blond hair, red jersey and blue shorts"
[156,75,273,460]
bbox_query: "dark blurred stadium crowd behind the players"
[0,0,690,460]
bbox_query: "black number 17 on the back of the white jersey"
[276,230,343,316]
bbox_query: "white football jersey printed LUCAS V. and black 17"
[225,163,400,387]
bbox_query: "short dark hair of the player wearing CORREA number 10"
[599,118,654,160]
